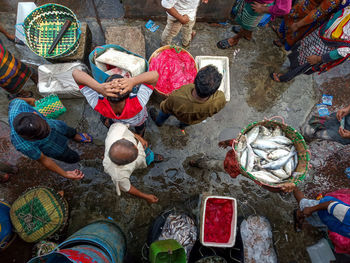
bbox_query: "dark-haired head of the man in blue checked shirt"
[12,112,51,141]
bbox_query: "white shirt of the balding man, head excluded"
[103,123,147,195]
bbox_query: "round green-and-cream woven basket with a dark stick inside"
[23,4,81,58]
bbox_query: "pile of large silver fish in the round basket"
[237,126,300,183]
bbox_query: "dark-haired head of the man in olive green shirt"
[194,65,222,98]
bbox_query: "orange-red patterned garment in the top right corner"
[284,0,341,47]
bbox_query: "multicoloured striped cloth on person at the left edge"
[0,41,32,94]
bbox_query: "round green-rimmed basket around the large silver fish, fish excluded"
[233,117,311,192]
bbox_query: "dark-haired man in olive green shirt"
[150,65,226,128]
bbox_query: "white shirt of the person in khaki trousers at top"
[162,0,200,21]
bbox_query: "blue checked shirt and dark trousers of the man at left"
[9,99,72,160]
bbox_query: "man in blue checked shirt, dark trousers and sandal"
[8,98,92,180]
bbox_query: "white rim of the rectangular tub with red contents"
[200,195,237,247]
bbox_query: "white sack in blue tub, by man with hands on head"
[95,48,146,77]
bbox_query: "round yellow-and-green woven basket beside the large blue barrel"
[10,187,68,242]
